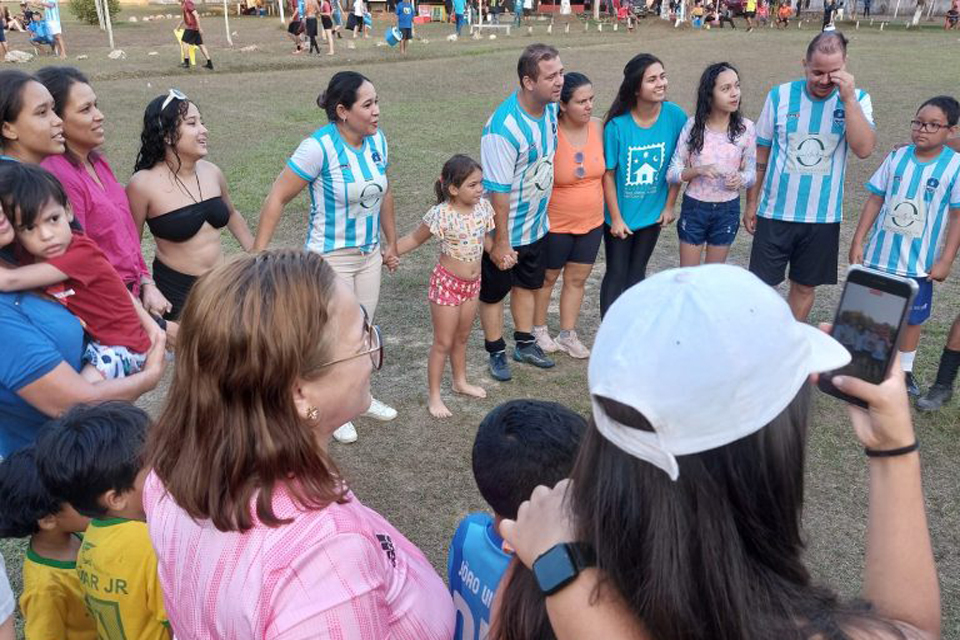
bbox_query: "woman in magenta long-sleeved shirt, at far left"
[37,67,170,316]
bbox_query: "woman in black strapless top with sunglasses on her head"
[127,89,253,320]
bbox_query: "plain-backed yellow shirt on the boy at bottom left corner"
[20,547,97,640]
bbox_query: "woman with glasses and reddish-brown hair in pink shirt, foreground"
[143,250,455,640]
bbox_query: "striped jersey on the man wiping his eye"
[757,80,873,223]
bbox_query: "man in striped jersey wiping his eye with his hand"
[743,31,876,320]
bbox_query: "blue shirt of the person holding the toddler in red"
[0,291,83,458]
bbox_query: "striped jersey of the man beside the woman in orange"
[480,93,557,247]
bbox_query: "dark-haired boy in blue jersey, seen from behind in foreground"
[447,400,587,640]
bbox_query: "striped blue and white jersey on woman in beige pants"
[287,123,388,253]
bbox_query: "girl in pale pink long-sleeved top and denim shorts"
[667,62,757,267]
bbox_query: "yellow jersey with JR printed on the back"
[77,518,171,640]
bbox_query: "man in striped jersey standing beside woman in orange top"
[480,44,563,381]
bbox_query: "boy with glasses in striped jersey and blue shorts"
[850,96,960,396]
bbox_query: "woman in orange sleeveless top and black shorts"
[533,72,605,358]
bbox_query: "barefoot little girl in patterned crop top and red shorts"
[397,155,493,418]
